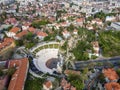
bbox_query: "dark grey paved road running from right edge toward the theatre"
[74,56,120,70]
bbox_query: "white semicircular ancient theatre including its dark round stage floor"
[30,42,63,74]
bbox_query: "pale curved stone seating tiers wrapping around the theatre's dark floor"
[31,42,59,74]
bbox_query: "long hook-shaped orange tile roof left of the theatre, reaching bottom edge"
[8,58,29,90]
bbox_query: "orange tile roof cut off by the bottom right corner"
[105,82,120,90]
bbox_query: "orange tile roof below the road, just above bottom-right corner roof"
[103,68,119,80]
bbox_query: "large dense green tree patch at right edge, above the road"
[99,30,120,57]
